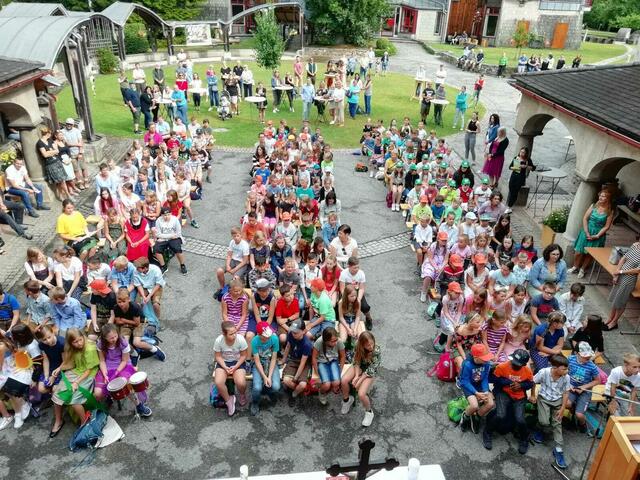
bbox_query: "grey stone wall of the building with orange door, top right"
[495,0,582,49]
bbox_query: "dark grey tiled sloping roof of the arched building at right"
[511,63,640,141]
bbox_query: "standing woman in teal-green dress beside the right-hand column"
[569,190,613,278]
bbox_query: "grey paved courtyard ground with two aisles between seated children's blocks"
[0,44,632,480]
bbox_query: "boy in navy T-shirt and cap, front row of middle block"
[281,320,313,405]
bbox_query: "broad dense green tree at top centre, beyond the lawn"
[307,0,391,46]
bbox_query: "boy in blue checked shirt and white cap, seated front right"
[567,342,600,433]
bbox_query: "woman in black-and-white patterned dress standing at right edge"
[602,236,640,331]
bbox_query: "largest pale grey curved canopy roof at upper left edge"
[0,14,95,68]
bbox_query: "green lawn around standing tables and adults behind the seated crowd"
[57,62,485,148]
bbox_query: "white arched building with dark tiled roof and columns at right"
[512,63,640,255]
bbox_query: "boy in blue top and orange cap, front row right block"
[458,344,494,433]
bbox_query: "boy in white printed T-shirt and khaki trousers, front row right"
[529,355,571,468]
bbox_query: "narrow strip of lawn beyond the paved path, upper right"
[429,42,627,66]
